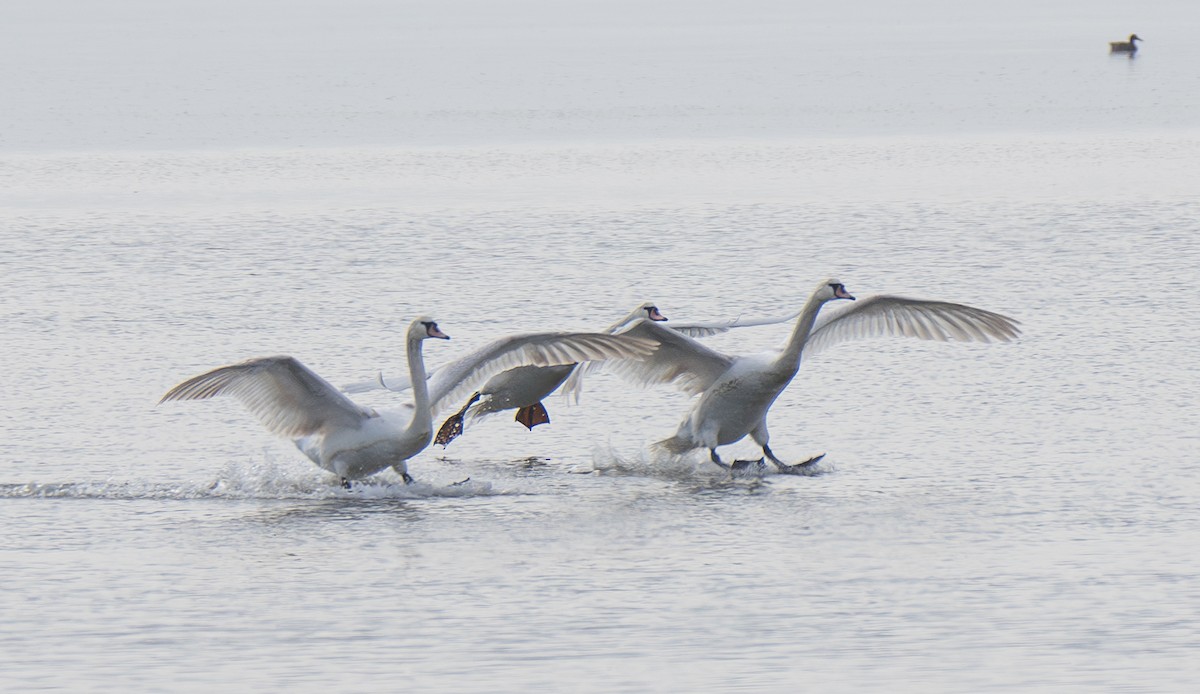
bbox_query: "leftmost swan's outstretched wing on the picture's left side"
[158,357,376,438]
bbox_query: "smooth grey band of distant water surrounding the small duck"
[0,0,1200,150]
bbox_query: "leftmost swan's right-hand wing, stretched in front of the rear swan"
[430,333,658,414]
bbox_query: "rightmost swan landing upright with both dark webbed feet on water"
[564,279,1020,473]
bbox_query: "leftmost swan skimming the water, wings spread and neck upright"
[158,317,656,487]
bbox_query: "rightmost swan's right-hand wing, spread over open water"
[804,294,1021,354]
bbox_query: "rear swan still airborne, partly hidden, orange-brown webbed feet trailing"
[343,301,798,447]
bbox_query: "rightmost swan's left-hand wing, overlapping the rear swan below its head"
[562,319,733,402]
